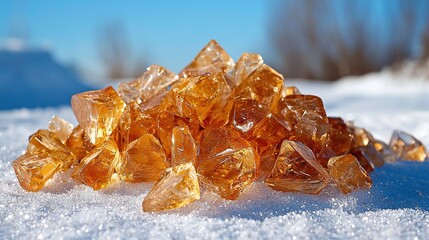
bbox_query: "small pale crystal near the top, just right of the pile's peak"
[228,53,264,87]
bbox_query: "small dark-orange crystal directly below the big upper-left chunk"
[65,125,94,160]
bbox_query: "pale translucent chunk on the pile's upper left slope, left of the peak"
[118,65,179,109]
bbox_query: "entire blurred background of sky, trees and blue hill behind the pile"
[0,0,429,109]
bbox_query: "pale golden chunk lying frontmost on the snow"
[143,163,200,212]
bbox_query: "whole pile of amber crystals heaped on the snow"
[13,41,426,211]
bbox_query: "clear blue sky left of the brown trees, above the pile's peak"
[0,0,272,79]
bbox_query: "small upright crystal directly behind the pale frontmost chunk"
[170,126,198,166]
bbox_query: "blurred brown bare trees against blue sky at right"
[270,0,429,80]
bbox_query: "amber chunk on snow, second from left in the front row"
[72,140,120,190]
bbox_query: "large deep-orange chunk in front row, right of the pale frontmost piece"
[196,128,259,200]
